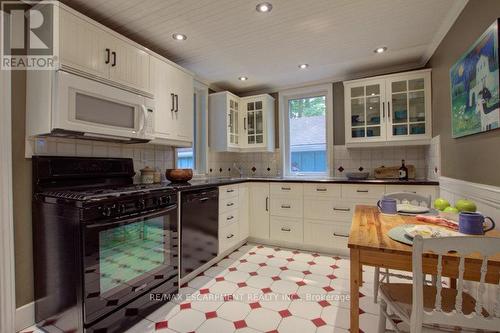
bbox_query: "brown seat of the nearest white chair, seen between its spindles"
[380,283,489,332]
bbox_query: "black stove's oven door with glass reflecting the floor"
[83,205,178,325]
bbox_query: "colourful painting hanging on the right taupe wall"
[450,19,500,138]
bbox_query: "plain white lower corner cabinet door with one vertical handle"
[248,183,270,239]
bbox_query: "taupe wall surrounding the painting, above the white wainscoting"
[427,0,500,186]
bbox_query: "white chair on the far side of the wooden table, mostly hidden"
[373,192,434,303]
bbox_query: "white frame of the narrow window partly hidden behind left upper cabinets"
[174,80,208,177]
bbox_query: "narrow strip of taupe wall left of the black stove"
[12,71,33,307]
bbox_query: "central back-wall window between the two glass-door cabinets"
[280,85,333,176]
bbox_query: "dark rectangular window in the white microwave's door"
[75,93,135,129]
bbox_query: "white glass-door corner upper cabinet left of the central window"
[209,91,274,152]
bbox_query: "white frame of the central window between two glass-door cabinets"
[278,84,333,178]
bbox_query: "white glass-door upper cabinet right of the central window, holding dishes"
[344,69,432,147]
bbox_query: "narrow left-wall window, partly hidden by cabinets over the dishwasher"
[175,81,208,175]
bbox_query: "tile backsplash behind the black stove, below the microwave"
[28,138,174,182]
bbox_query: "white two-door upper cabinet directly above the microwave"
[54,4,151,96]
